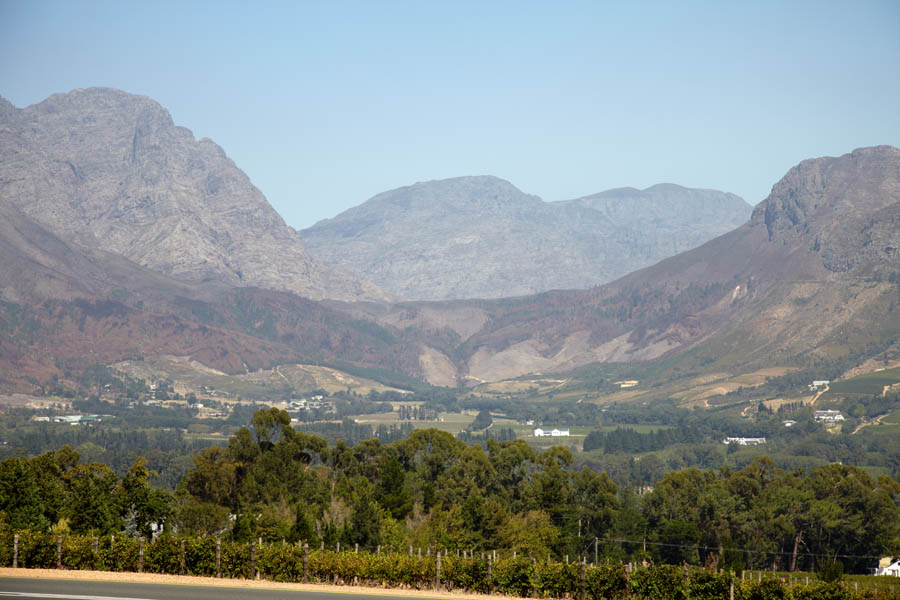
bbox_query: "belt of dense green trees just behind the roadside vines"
[0,409,900,572]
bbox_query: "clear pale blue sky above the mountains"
[0,0,900,229]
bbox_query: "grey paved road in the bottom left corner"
[0,577,440,600]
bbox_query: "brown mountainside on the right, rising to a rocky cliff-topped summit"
[356,146,900,381]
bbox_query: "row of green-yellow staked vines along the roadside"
[0,531,900,600]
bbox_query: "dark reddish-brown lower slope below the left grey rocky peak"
[0,202,421,392]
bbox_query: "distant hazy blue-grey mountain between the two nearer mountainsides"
[301,177,751,300]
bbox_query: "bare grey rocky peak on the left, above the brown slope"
[0,88,385,300]
